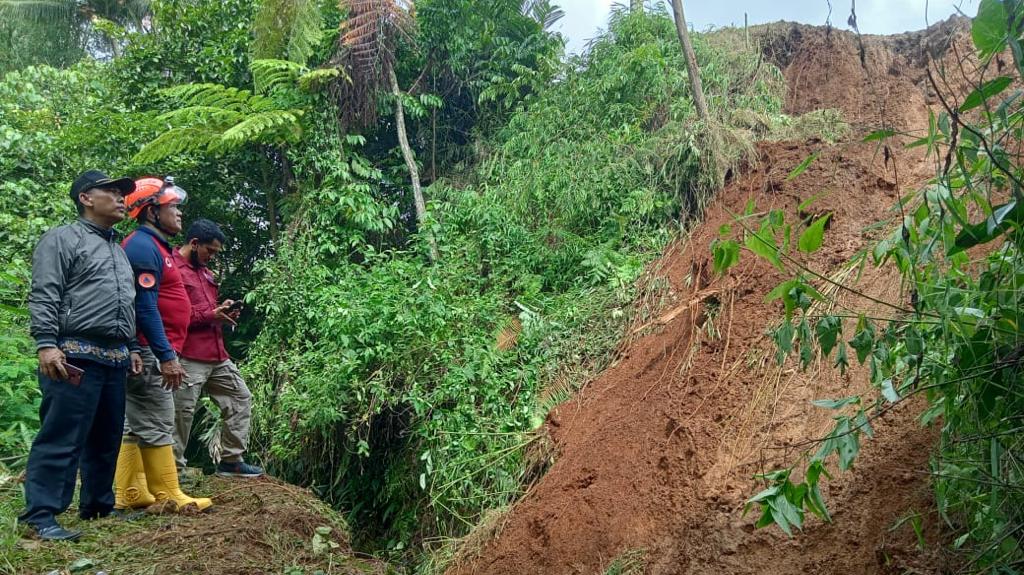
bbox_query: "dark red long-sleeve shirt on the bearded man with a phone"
[174,250,228,361]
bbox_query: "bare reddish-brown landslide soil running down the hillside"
[453,20,971,575]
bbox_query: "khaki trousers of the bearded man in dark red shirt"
[174,358,252,470]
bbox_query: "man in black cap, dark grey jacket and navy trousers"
[18,170,141,540]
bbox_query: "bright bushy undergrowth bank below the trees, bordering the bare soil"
[248,5,781,548]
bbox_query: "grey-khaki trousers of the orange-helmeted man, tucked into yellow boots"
[124,347,174,447]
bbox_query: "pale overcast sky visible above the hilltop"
[553,0,978,52]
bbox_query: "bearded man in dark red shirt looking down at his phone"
[174,219,263,477]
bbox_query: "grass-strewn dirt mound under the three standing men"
[9,476,385,575]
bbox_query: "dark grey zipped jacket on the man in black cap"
[29,219,135,349]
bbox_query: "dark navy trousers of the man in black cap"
[17,359,128,528]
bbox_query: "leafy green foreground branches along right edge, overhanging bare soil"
[714,0,1024,573]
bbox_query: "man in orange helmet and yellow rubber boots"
[114,177,213,511]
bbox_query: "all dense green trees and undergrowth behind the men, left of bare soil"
[0,0,841,568]
